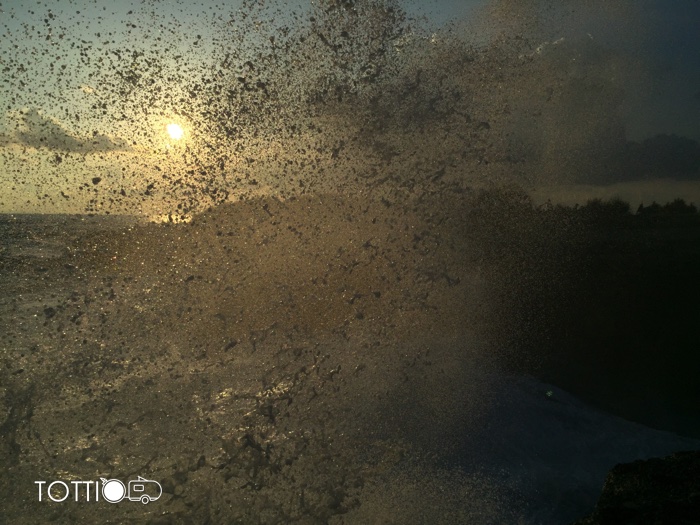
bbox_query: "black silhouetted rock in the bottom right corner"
[572,451,700,525]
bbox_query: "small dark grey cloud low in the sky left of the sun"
[0,109,131,153]
